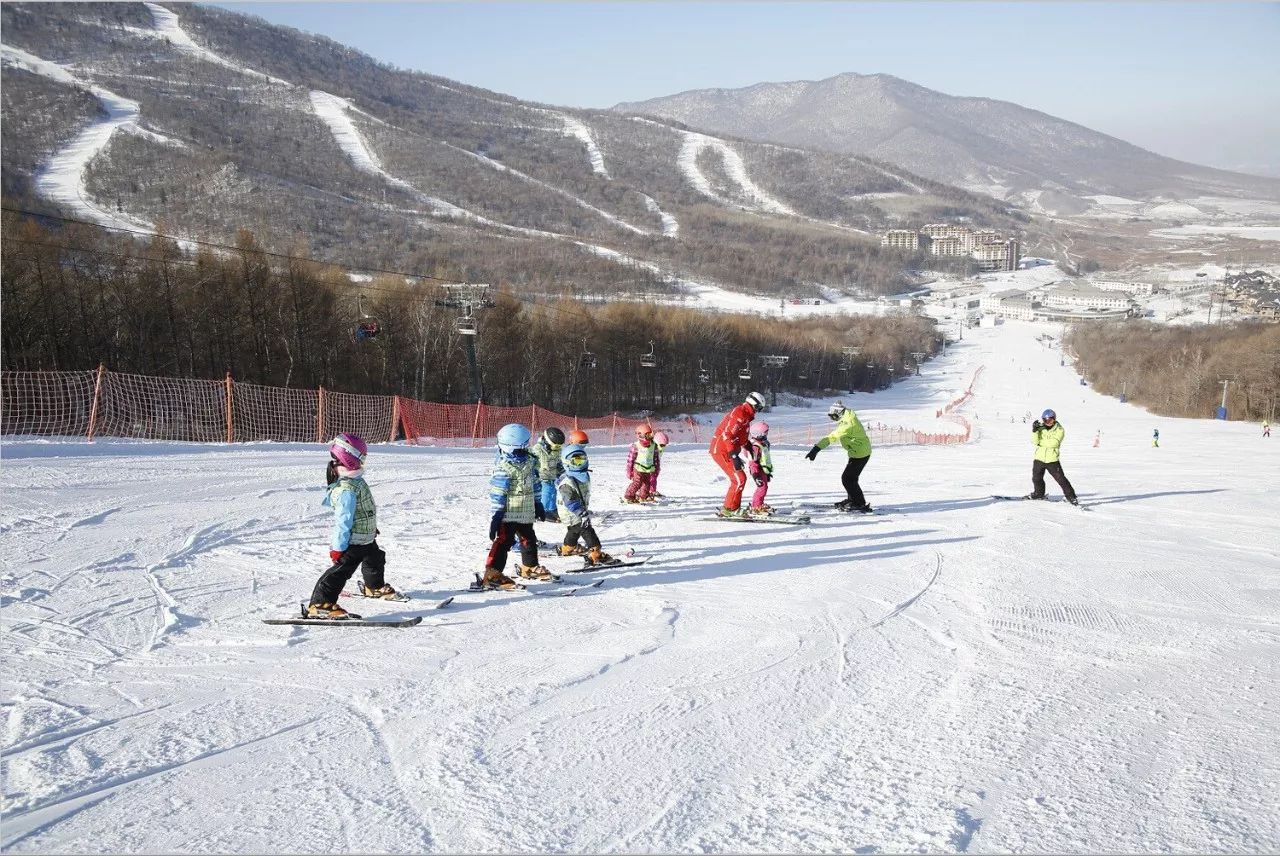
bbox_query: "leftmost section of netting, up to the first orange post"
[0,371,101,436]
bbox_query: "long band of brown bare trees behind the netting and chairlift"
[3,212,941,416]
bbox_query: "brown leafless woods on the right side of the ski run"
[1066,321,1280,420]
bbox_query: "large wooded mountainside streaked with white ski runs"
[3,3,1025,296]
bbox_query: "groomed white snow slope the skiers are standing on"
[0,324,1280,853]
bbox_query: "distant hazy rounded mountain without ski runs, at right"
[614,74,1280,214]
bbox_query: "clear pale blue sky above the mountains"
[216,0,1280,175]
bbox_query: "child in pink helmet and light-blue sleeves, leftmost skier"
[307,434,398,621]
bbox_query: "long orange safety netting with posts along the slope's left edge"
[0,369,982,447]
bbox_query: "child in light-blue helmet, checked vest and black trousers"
[480,422,556,590]
